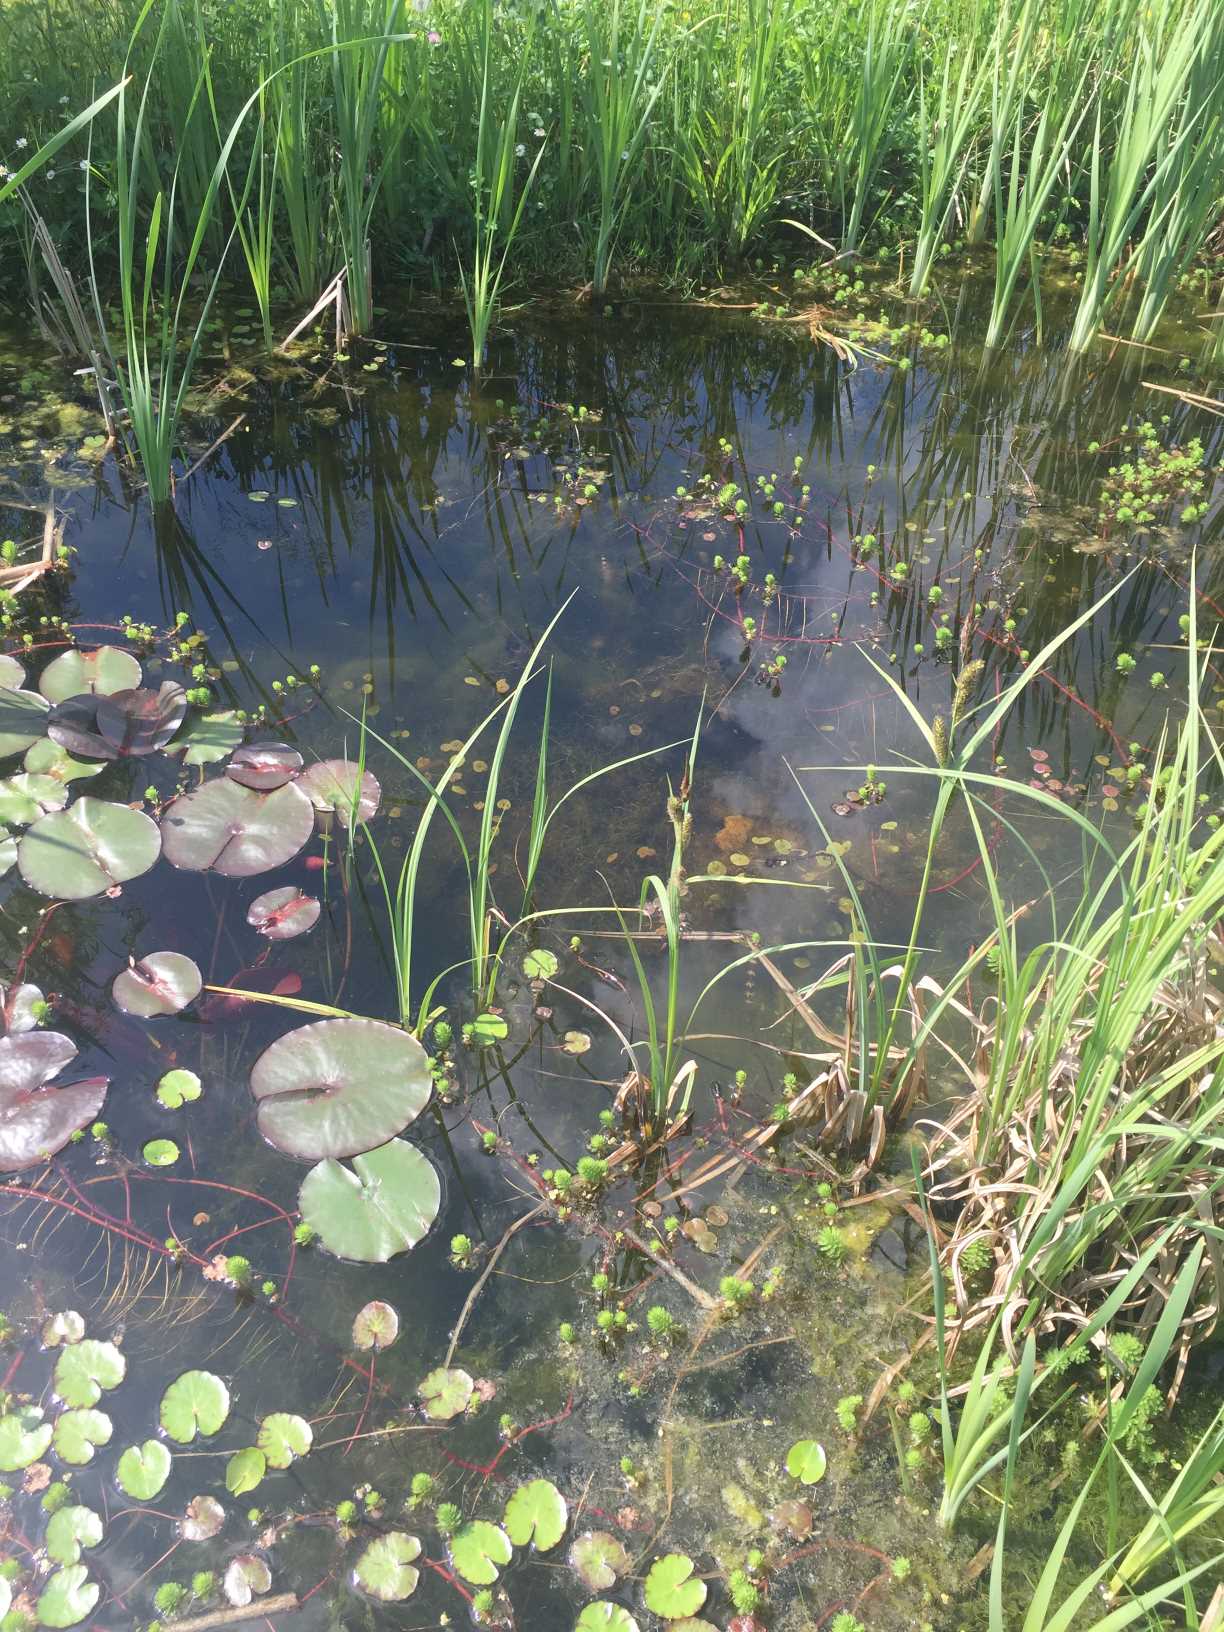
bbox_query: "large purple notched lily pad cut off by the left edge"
[0,1031,109,1173]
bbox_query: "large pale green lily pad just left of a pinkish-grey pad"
[16,795,162,901]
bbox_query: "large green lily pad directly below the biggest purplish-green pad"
[297,1139,442,1263]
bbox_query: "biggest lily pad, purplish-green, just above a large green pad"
[251,1020,432,1162]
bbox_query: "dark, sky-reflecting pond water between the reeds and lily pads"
[0,283,1224,1632]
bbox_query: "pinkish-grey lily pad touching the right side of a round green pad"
[162,775,315,878]
